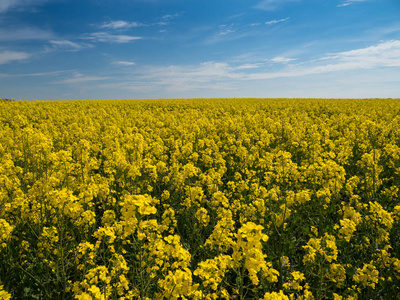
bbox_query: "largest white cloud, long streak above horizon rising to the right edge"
[119,40,400,91]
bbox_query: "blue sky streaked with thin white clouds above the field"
[0,0,400,100]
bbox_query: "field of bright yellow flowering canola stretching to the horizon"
[0,99,400,300]
